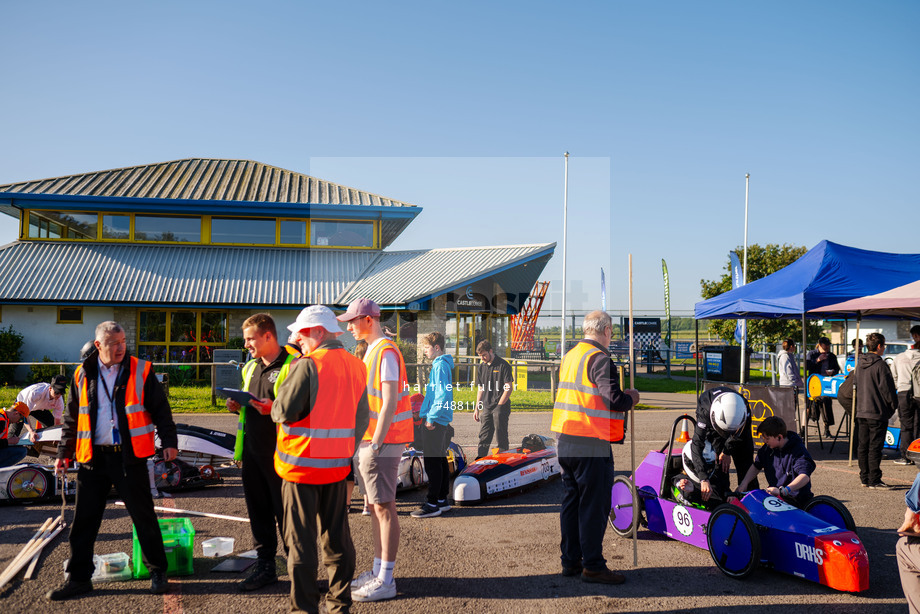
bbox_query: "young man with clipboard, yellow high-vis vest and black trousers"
[227,313,294,591]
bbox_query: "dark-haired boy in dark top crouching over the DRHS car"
[738,416,815,507]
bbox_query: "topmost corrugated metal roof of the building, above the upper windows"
[0,158,415,207]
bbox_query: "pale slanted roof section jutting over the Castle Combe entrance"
[335,243,556,305]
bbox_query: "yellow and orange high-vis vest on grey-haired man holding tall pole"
[550,341,625,442]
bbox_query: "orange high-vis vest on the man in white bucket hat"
[275,348,367,484]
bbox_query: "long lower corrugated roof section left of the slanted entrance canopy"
[0,241,380,307]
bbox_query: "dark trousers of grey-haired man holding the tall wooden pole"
[558,442,613,571]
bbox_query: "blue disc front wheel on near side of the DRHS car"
[706,504,760,578]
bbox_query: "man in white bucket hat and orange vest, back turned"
[269,305,368,612]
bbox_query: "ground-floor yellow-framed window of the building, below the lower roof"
[137,309,229,375]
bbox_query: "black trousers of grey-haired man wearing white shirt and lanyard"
[67,448,167,582]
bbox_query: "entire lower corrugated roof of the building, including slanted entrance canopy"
[0,241,555,307]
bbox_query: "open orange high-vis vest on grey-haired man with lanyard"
[74,356,156,463]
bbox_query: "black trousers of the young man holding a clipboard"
[242,448,284,561]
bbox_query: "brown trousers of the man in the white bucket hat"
[281,480,355,612]
